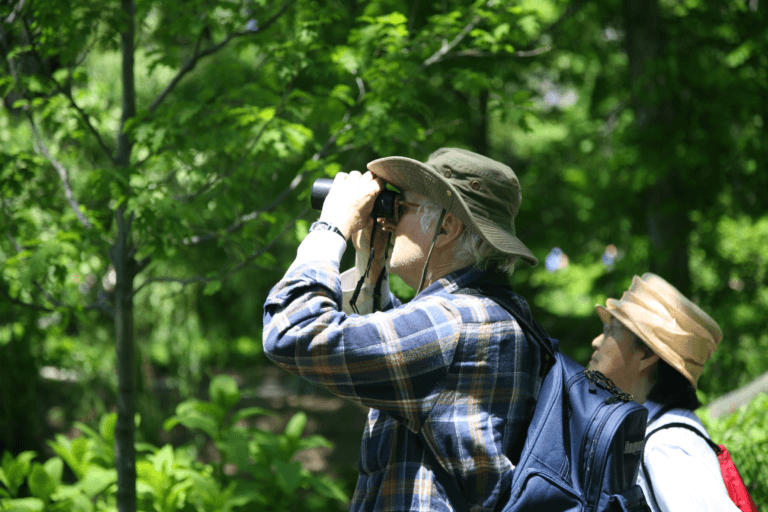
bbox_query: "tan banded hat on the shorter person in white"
[595,272,723,389]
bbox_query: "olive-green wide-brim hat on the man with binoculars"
[368,148,538,265]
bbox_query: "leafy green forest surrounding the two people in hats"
[0,0,768,511]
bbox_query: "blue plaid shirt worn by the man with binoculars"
[263,255,541,512]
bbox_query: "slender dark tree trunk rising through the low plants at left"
[110,0,136,512]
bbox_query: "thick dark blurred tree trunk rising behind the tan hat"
[624,0,692,295]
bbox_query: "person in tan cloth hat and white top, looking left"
[589,272,739,512]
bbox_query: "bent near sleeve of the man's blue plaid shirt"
[263,261,461,431]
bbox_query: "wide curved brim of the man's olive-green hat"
[368,156,539,266]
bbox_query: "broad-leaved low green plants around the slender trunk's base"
[0,376,349,512]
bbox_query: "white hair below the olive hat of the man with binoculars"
[418,201,518,276]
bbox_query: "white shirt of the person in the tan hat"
[637,401,739,512]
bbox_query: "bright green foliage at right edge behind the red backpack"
[698,393,768,510]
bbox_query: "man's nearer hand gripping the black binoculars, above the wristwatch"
[320,171,384,240]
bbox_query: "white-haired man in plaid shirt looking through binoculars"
[263,148,541,512]
